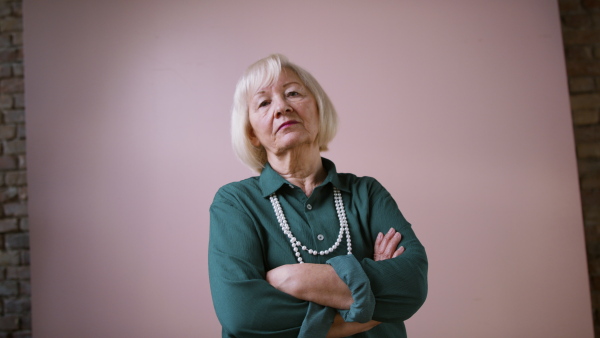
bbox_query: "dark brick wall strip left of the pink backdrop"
[0,0,31,338]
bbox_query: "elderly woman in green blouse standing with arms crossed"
[209,55,427,337]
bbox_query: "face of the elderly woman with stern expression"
[249,68,319,155]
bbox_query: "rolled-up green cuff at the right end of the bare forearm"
[326,255,375,323]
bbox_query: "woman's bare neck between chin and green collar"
[267,149,327,196]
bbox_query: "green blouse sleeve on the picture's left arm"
[209,187,333,337]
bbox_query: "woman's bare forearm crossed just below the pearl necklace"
[267,263,353,310]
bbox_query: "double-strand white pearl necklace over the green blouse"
[269,187,352,263]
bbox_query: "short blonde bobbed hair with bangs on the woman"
[231,54,338,173]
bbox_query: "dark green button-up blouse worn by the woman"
[208,158,427,337]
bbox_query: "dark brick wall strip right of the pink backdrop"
[559,0,600,337]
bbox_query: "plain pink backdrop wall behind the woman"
[25,0,592,338]
